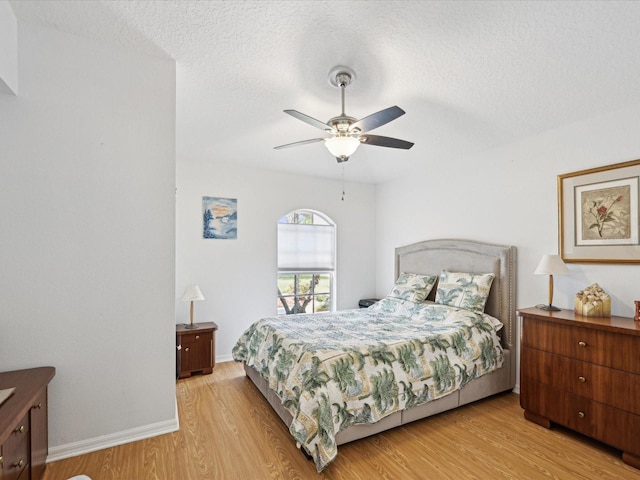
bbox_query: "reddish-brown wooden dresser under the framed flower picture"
[518,308,640,468]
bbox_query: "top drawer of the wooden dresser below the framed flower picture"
[522,318,640,374]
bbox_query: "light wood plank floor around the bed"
[43,362,640,480]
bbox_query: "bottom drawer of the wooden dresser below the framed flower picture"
[520,378,640,455]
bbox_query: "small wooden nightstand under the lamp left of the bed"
[176,322,218,378]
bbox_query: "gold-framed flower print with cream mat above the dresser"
[558,160,640,263]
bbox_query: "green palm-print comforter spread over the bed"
[233,298,503,472]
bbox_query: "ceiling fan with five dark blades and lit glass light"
[274,67,413,163]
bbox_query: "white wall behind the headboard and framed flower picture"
[376,105,640,317]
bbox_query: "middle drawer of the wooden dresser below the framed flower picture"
[520,347,640,414]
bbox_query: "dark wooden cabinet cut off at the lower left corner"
[0,367,56,480]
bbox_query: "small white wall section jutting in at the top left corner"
[0,0,18,95]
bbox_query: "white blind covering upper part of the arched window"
[278,223,336,271]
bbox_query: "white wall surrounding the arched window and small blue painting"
[176,158,375,361]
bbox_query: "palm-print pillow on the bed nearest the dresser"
[436,270,495,313]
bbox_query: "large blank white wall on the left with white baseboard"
[0,22,176,460]
